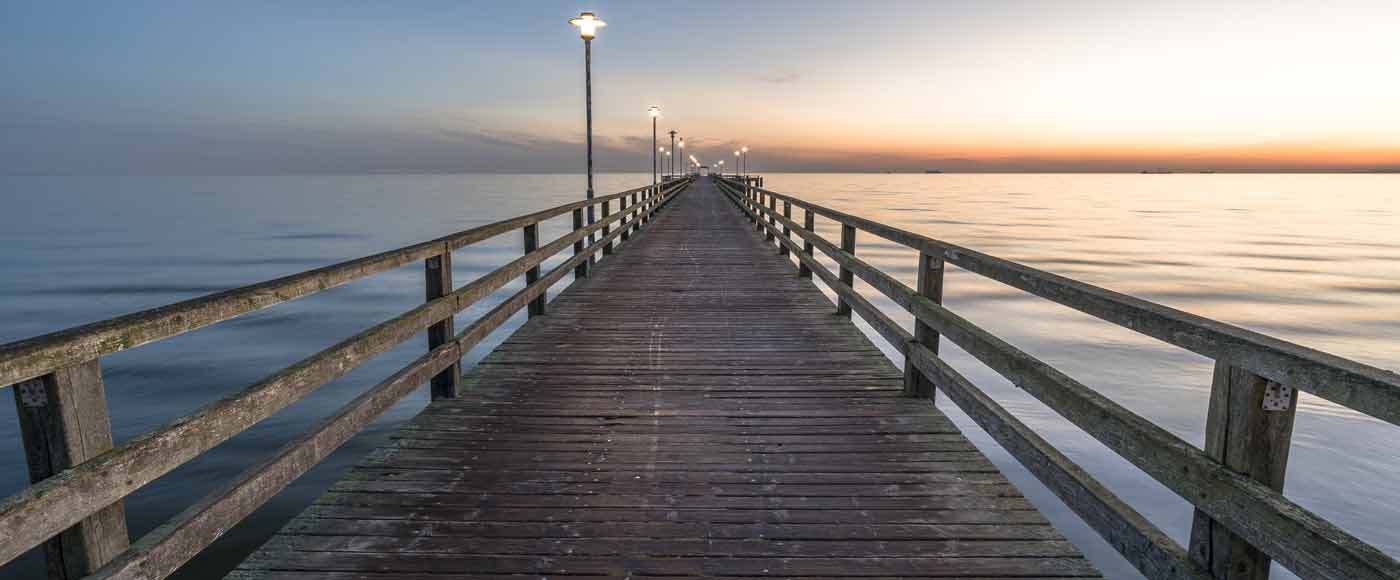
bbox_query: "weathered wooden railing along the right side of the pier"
[721,179,1400,580]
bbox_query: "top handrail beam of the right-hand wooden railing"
[735,184,1400,424]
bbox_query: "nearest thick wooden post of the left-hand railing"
[11,360,130,580]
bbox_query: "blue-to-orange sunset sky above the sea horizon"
[0,0,1400,175]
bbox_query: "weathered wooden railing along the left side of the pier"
[0,179,689,579]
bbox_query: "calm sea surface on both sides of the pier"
[0,174,1400,577]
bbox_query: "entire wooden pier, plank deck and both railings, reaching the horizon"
[0,175,1400,580]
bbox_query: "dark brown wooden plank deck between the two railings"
[231,179,1099,580]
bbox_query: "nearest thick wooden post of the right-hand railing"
[1190,361,1298,580]
